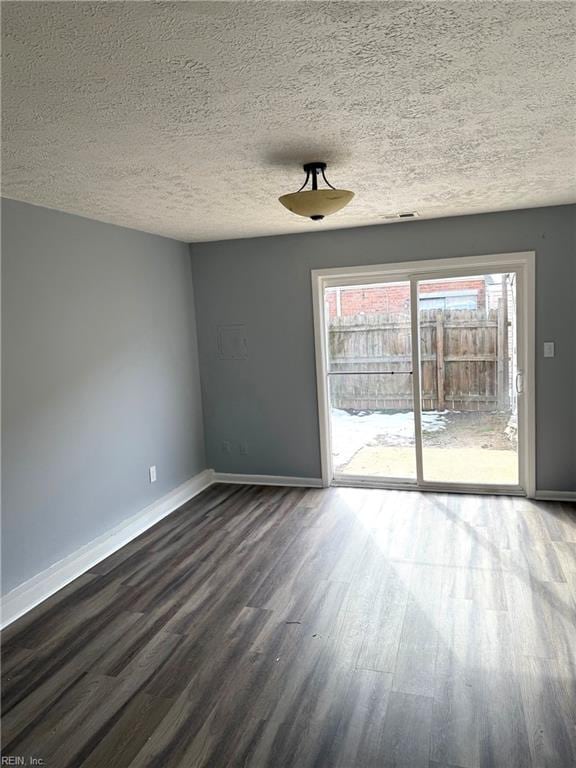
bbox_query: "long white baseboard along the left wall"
[0,469,214,627]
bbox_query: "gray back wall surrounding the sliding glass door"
[191,206,576,490]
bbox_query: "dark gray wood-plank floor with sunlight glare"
[3,485,576,768]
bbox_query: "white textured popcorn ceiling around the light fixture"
[2,0,576,241]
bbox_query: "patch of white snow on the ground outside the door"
[332,408,447,467]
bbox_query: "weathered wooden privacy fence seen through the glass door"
[328,302,510,411]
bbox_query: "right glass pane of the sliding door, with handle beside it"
[418,272,519,486]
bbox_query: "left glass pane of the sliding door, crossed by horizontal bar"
[324,281,416,481]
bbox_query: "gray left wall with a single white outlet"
[2,200,206,592]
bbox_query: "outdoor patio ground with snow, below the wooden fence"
[332,410,518,485]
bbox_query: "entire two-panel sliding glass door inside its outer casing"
[320,258,526,492]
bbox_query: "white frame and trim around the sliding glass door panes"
[311,251,536,498]
